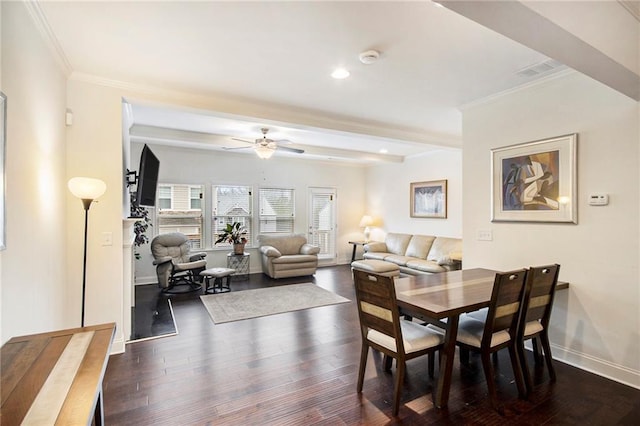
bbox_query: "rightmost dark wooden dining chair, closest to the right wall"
[518,264,560,395]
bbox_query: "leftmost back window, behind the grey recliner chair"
[157,184,203,249]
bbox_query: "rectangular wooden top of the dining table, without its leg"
[395,268,569,319]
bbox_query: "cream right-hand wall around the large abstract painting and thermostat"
[463,73,640,387]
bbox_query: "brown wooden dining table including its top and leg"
[395,268,568,408]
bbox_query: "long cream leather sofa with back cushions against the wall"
[363,232,462,275]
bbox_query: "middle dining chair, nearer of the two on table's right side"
[456,269,527,413]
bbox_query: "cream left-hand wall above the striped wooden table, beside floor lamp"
[0,2,70,343]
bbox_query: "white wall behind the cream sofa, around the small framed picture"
[360,149,462,240]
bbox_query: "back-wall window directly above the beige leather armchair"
[260,188,295,234]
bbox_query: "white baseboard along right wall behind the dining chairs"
[551,343,640,389]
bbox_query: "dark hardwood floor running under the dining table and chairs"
[104,266,640,425]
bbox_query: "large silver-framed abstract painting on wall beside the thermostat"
[491,133,578,223]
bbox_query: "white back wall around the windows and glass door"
[132,143,365,284]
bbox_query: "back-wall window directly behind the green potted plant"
[211,185,253,247]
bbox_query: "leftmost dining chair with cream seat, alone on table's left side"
[353,269,444,416]
